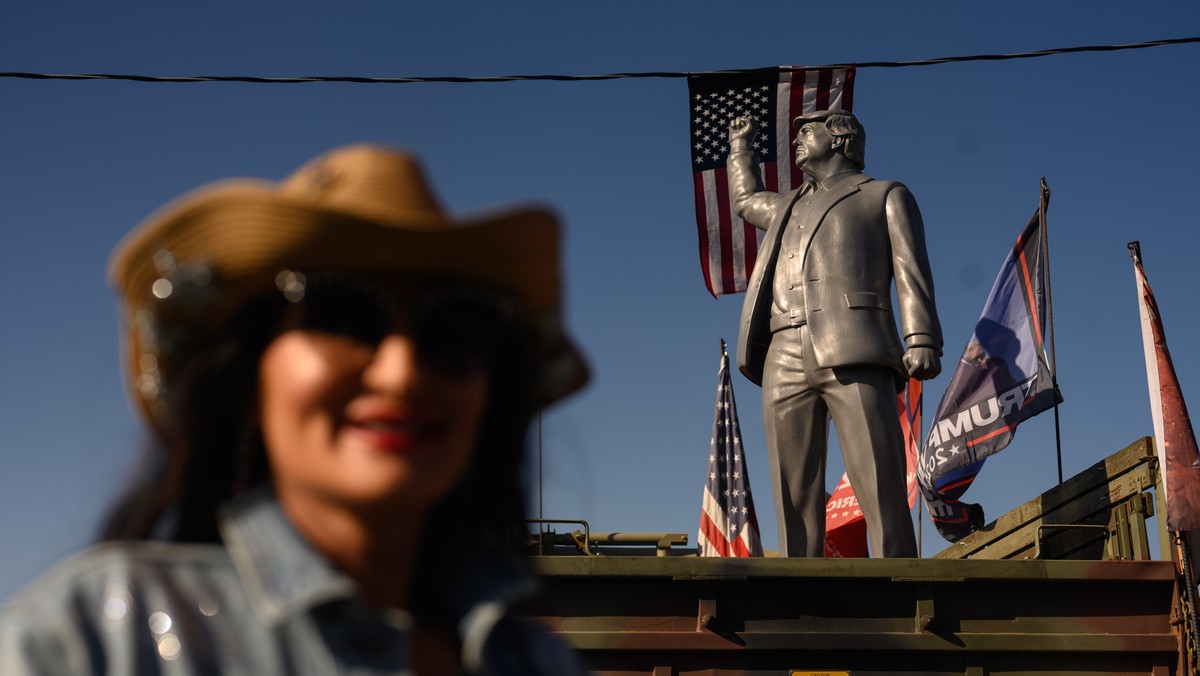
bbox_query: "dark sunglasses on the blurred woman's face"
[275,270,516,377]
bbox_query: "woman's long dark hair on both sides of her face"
[101,297,536,554]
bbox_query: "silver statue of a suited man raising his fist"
[728,110,942,557]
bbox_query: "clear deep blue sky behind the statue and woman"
[0,1,1200,597]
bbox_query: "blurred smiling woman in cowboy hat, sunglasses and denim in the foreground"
[0,145,587,676]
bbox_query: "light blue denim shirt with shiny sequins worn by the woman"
[0,495,584,676]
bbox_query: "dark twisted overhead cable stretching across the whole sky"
[0,37,1200,84]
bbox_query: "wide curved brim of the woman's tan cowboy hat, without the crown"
[109,179,588,419]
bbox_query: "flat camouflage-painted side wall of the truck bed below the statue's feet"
[527,557,1181,676]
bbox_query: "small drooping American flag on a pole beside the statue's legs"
[696,345,762,556]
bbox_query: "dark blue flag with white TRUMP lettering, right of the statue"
[917,210,1057,543]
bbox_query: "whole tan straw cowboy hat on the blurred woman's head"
[109,144,587,421]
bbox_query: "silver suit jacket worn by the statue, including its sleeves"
[728,152,942,385]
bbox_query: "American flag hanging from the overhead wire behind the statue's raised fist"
[688,68,854,298]
